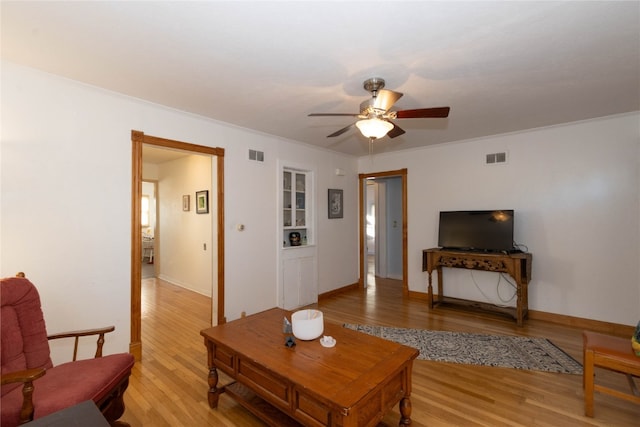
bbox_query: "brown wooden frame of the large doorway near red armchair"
[129,130,226,360]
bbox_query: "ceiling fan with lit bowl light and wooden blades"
[309,77,450,141]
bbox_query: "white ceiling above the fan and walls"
[1,0,640,155]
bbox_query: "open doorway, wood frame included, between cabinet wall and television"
[359,169,409,293]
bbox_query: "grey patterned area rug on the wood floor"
[343,324,582,375]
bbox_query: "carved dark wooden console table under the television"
[422,248,532,326]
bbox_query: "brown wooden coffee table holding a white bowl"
[200,308,418,427]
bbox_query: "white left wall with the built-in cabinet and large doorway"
[0,61,358,362]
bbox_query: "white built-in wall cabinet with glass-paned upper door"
[279,167,318,310]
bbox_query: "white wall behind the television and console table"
[359,113,640,325]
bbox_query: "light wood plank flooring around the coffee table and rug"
[122,279,640,427]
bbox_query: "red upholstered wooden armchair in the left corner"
[0,277,134,427]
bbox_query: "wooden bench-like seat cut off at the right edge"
[582,331,640,417]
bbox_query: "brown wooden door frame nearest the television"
[358,168,409,295]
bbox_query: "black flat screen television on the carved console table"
[438,209,514,252]
